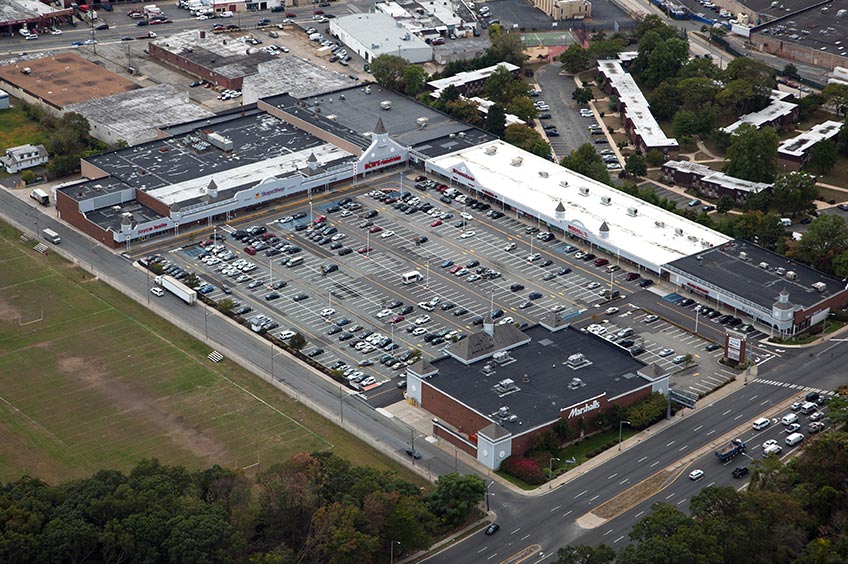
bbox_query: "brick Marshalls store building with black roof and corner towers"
[407,314,668,470]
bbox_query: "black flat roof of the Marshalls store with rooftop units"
[427,326,648,434]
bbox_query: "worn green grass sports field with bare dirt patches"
[0,220,420,482]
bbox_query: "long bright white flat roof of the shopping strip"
[431,140,730,266]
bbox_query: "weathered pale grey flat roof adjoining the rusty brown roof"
[65,84,215,145]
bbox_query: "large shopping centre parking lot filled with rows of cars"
[139,170,760,405]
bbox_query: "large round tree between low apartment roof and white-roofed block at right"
[724,123,780,182]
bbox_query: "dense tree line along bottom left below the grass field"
[0,452,485,564]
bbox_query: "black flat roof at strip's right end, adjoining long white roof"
[669,239,845,309]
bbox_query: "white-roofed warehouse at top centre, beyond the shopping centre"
[330,12,433,63]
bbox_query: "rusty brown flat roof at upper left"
[0,53,141,110]
